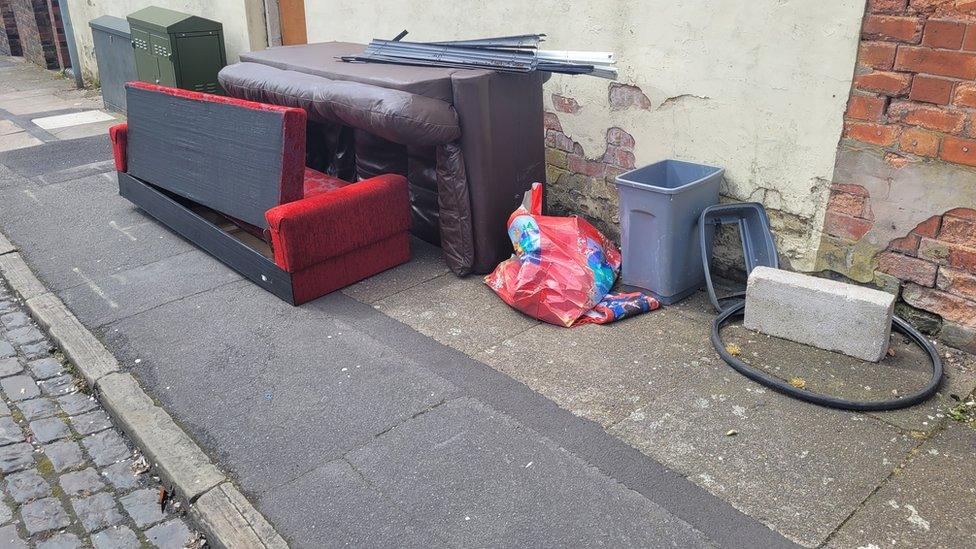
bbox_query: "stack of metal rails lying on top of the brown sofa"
[340,31,617,80]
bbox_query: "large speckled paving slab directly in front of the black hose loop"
[610,352,918,547]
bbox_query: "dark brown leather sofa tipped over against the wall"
[219,42,547,275]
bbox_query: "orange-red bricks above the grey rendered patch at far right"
[844,0,976,166]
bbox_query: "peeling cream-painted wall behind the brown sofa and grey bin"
[305,0,865,269]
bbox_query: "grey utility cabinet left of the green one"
[88,15,136,113]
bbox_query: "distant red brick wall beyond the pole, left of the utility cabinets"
[7,0,70,69]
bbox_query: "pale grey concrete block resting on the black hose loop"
[745,267,895,362]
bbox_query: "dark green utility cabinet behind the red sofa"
[128,6,227,94]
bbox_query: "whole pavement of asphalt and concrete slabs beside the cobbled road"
[0,58,976,548]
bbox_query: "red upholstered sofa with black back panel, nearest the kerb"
[109,82,410,305]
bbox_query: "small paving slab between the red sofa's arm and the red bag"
[375,274,539,355]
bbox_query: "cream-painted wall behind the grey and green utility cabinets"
[68,0,268,79]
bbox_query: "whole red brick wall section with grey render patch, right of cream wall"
[817,0,976,352]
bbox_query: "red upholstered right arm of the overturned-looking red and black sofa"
[265,174,410,273]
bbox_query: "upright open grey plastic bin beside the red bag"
[616,160,725,304]
